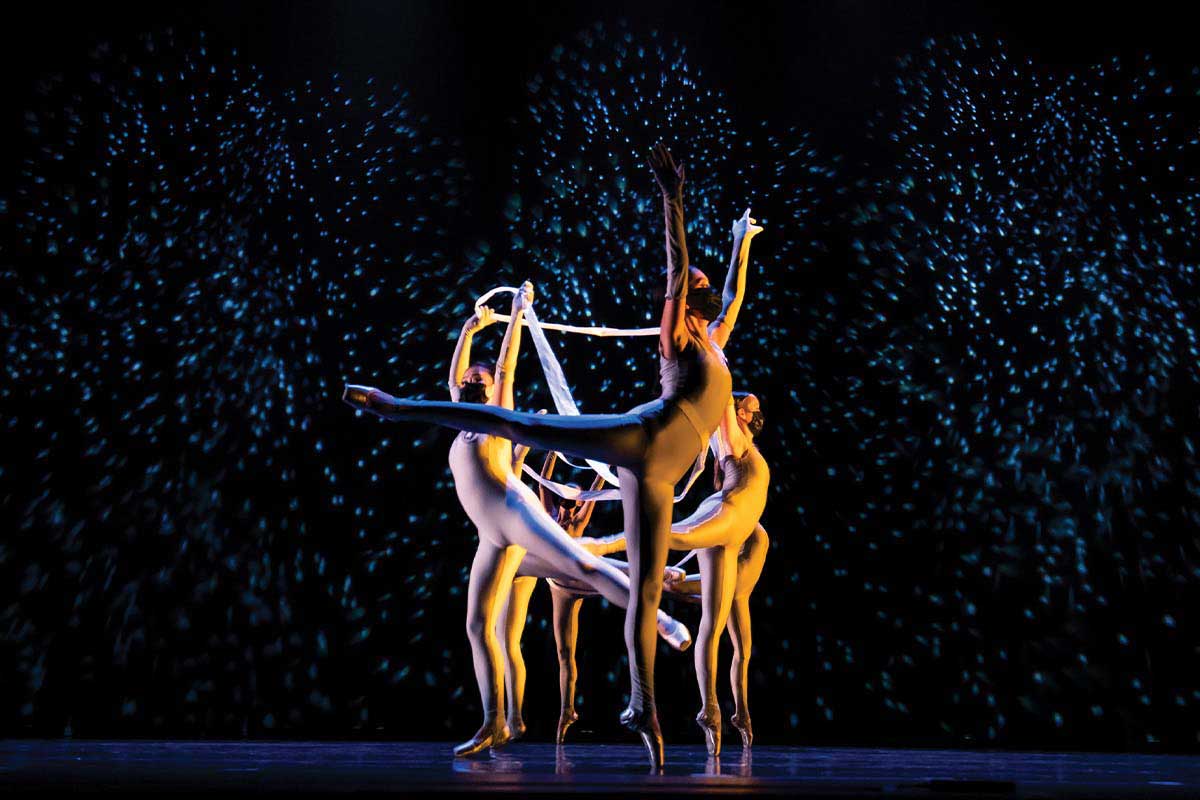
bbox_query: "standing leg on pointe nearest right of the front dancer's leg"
[696,547,738,756]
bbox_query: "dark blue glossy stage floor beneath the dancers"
[0,740,1200,798]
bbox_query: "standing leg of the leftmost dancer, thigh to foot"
[455,533,524,756]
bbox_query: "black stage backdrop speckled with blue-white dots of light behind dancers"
[0,1,1200,751]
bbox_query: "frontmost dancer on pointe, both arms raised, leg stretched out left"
[342,145,762,769]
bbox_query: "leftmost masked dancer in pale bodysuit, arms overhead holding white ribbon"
[439,282,690,756]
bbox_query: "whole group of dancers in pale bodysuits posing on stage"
[343,144,769,768]
